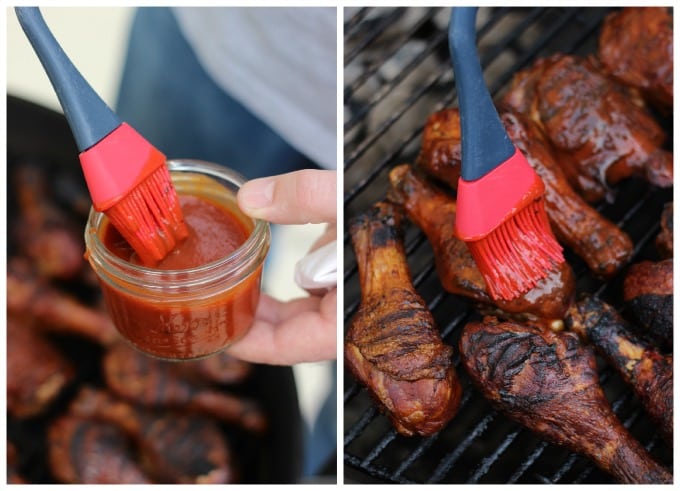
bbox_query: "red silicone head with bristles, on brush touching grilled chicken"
[456,150,564,301]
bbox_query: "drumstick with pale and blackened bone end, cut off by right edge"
[566,297,673,445]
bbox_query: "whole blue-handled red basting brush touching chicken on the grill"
[448,7,564,300]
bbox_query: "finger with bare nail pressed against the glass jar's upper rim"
[236,169,337,224]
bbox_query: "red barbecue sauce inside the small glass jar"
[100,195,262,359]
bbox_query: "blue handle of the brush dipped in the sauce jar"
[15,7,122,152]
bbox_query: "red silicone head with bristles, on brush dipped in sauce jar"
[80,123,189,266]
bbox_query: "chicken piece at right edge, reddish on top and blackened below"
[623,259,673,348]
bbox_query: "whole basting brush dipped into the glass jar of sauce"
[15,7,188,266]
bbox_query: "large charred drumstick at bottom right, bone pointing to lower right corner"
[459,317,673,483]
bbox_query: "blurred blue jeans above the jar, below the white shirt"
[116,7,317,179]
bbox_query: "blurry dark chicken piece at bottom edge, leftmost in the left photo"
[48,414,150,484]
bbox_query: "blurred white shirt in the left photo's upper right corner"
[173,7,337,169]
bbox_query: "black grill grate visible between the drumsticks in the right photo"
[344,8,672,483]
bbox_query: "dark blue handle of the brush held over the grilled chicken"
[448,7,515,181]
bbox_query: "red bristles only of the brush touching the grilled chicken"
[467,198,564,301]
